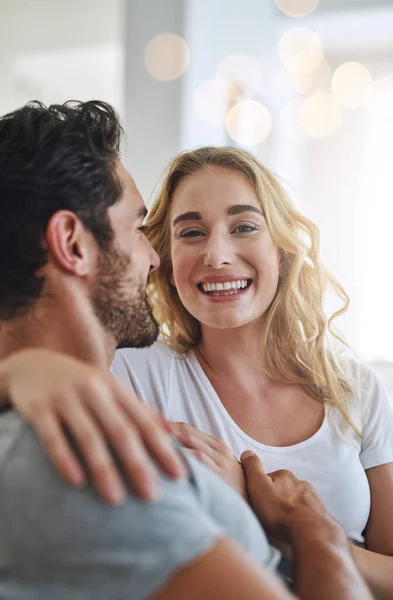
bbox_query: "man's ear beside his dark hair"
[45,210,94,277]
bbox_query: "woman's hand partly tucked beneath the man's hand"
[169,422,247,499]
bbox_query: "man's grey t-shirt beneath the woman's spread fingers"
[0,411,279,600]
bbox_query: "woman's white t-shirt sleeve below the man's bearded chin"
[110,342,172,416]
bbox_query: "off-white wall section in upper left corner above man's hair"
[0,0,124,114]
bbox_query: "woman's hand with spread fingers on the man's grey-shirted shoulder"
[29,373,186,504]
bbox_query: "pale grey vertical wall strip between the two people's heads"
[125,0,185,202]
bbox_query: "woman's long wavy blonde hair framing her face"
[146,147,360,435]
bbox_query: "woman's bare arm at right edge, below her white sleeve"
[352,464,393,600]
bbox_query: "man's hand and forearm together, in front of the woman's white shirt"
[241,451,372,600]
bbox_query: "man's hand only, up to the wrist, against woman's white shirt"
[241,451,338,543]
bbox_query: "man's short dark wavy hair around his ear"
[0,101,123,321]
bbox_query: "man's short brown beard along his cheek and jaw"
[92,245,159,348]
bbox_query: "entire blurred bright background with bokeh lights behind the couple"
[0,0,393,380]
